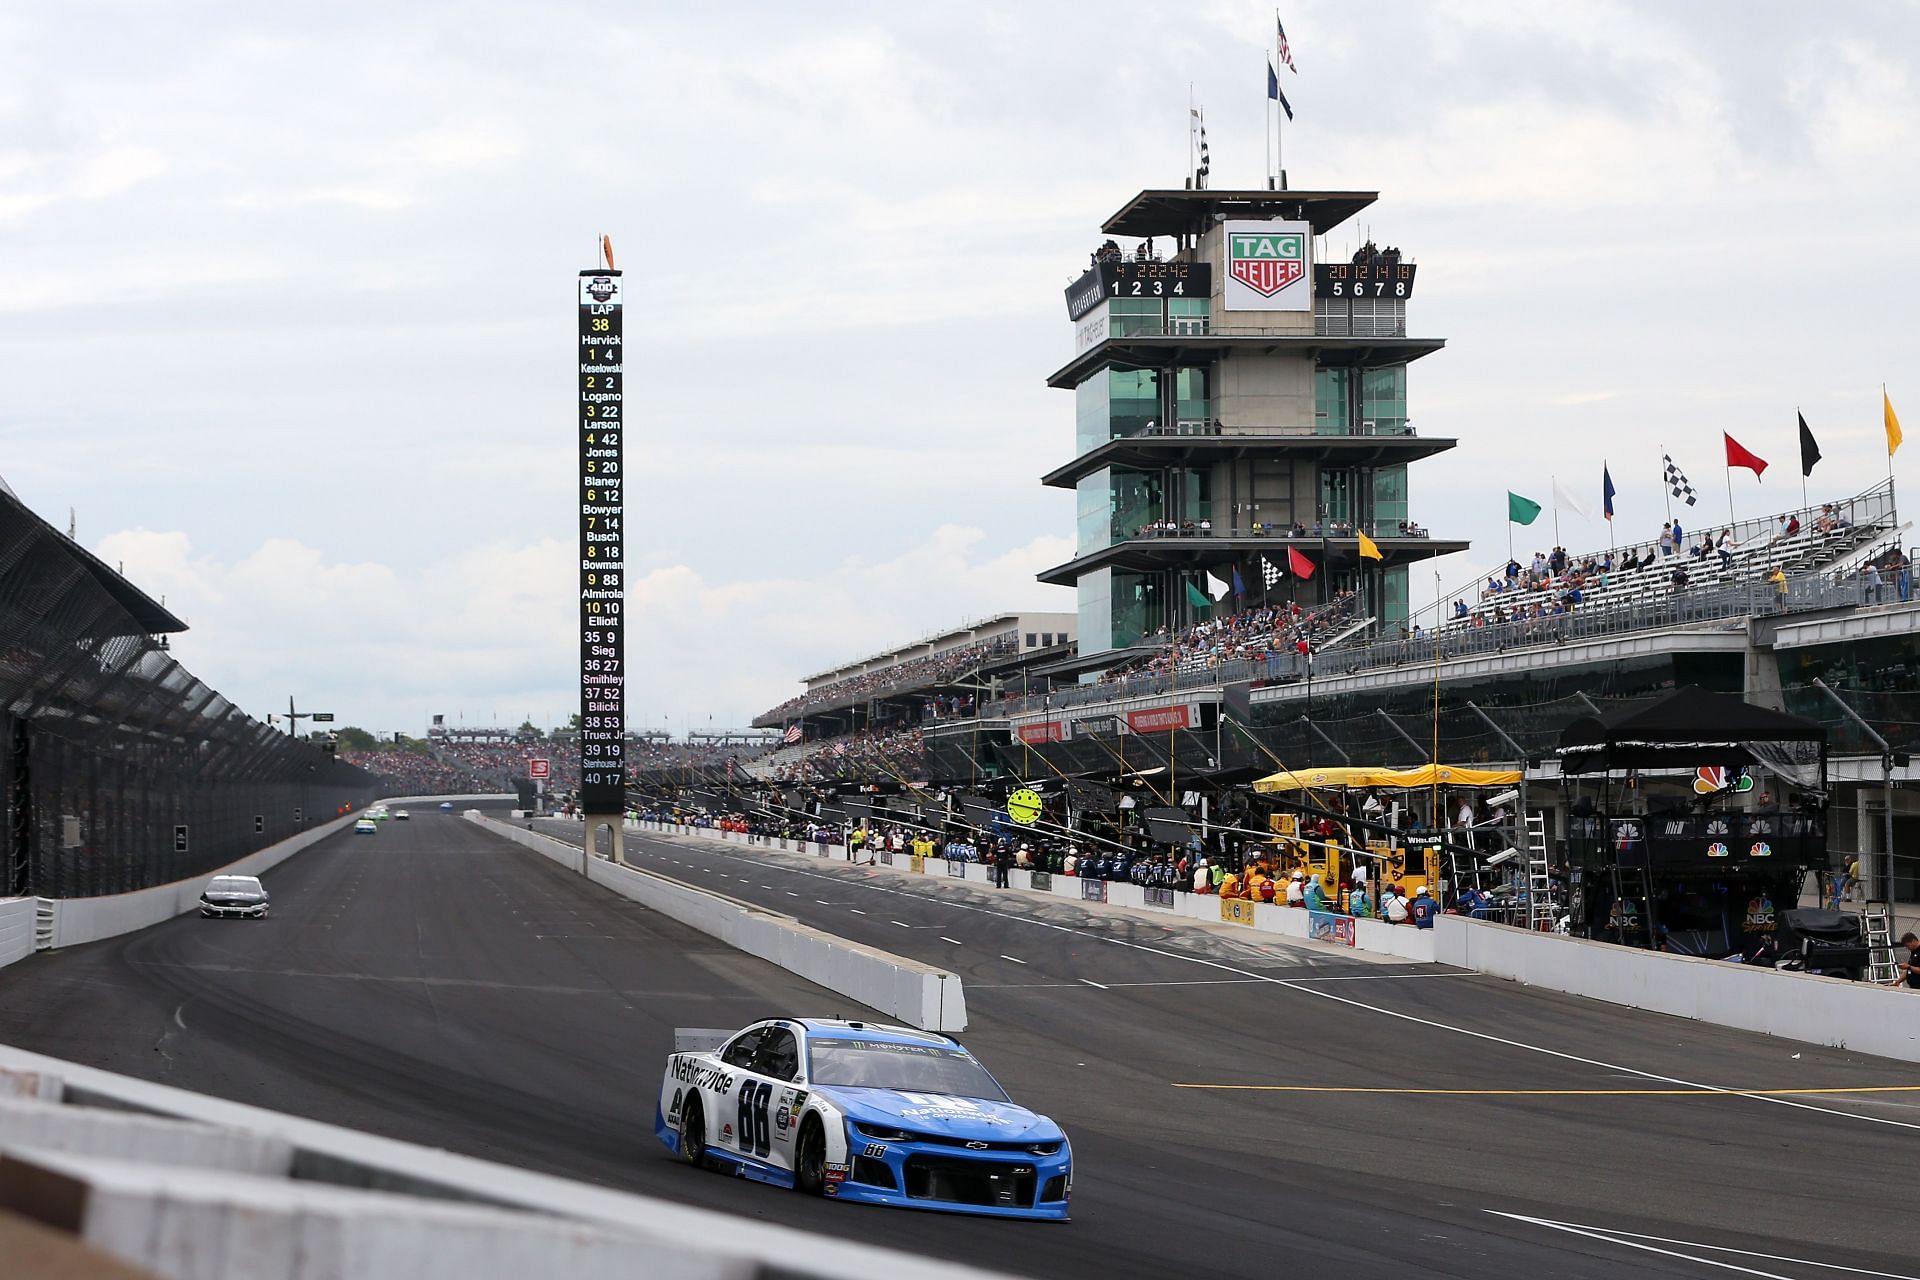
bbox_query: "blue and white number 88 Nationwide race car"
[653,1017,1073,1219]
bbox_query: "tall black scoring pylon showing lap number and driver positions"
[580,271,626,814]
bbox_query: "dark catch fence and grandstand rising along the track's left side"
[0,489,374,898]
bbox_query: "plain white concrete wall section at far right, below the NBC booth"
[1434,915,1920,1061]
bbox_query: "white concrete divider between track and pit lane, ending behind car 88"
[467,812,966,1031]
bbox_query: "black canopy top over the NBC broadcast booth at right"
[1557,685,1826,775]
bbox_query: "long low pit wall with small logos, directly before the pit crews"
[637,821,1434,961]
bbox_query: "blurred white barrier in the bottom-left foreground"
[0,1046,1013,1280]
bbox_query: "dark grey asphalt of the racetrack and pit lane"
[0,812,1920,1280]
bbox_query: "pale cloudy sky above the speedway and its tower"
[0,0,1920,733]
